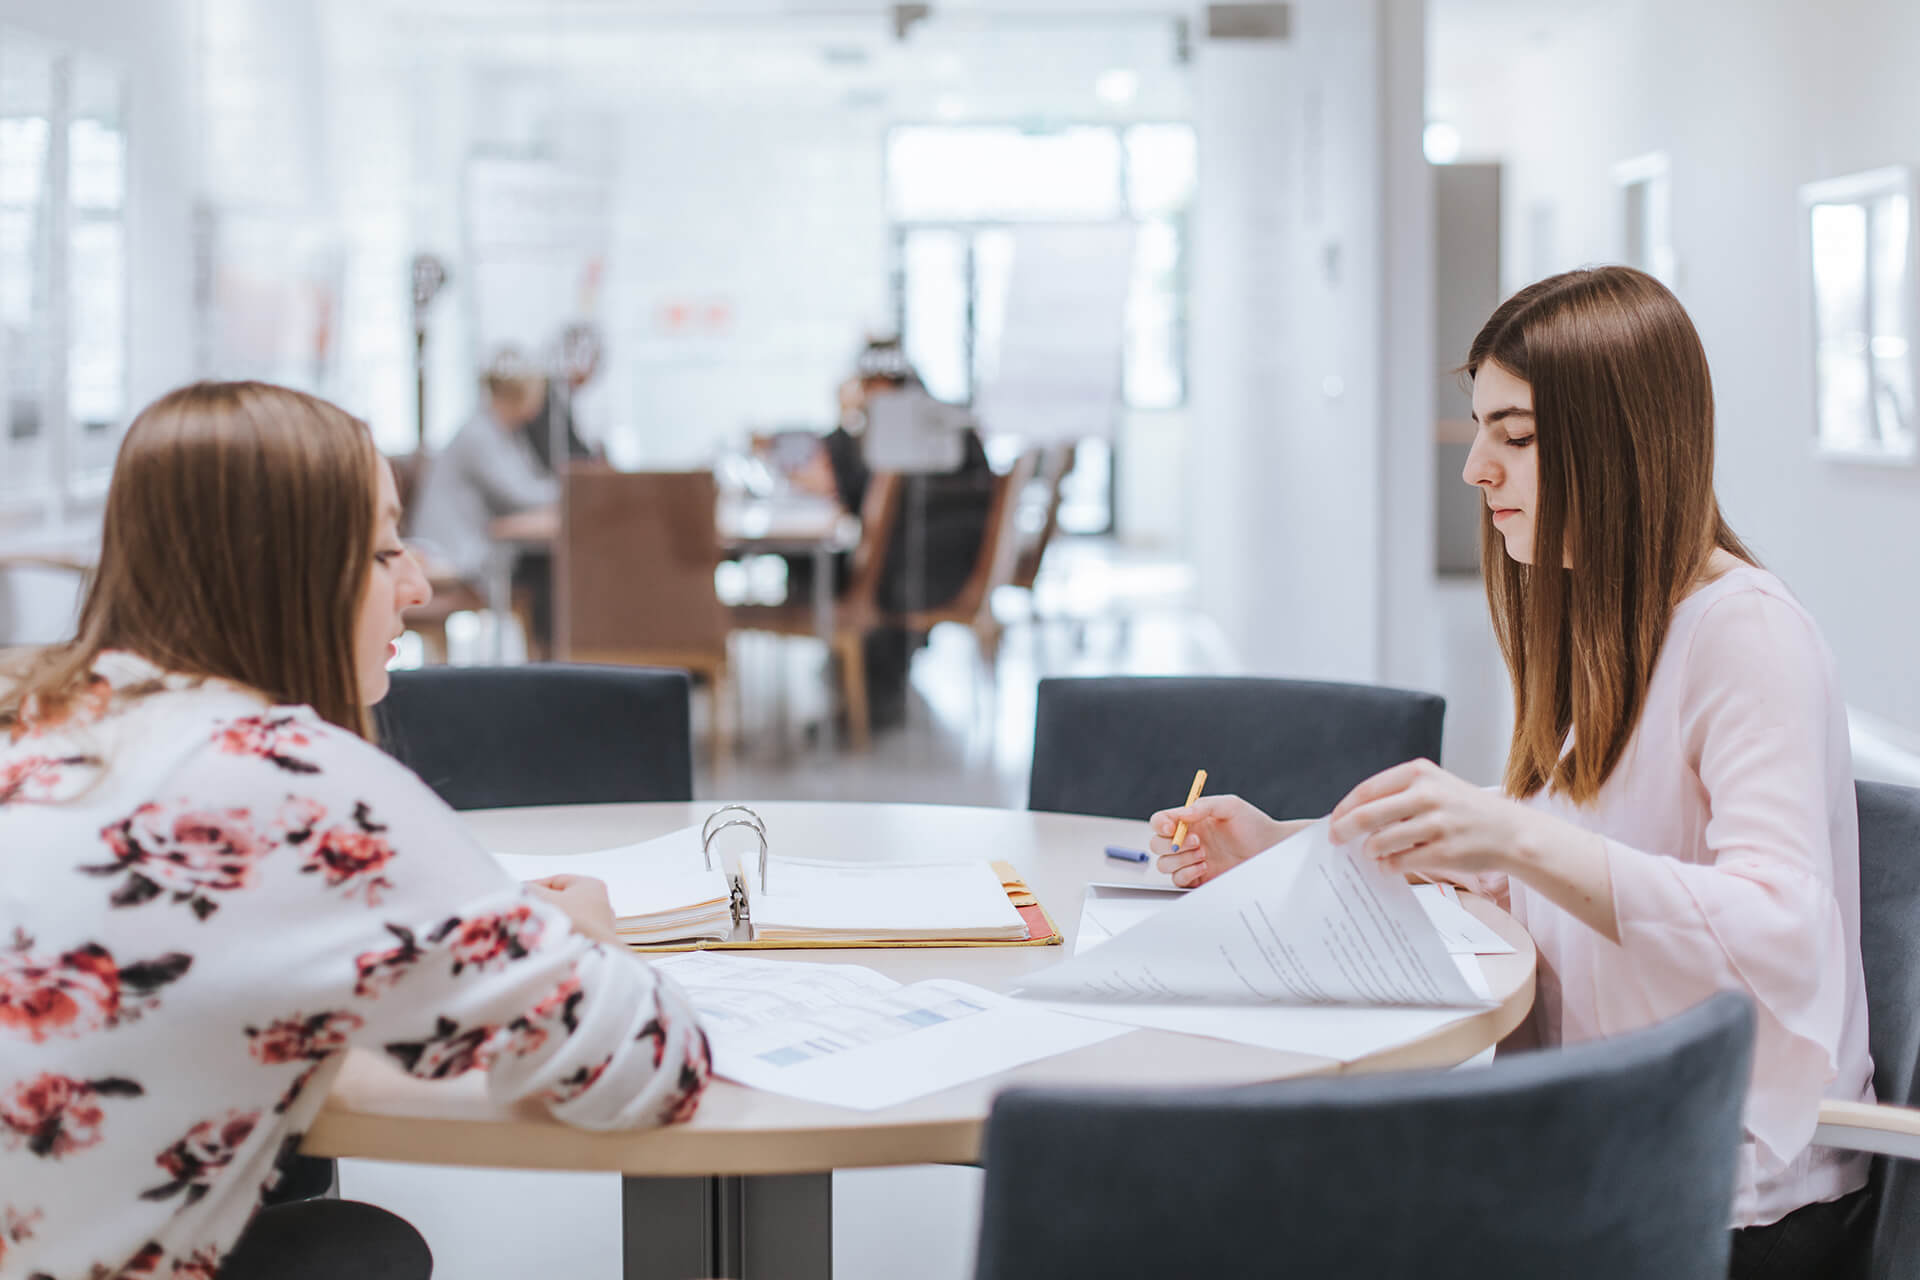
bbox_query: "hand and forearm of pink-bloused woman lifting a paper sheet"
[1329,760,1619,942]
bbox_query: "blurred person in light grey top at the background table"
[409,347,561,654]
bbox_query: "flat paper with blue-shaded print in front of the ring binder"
[653,952,1127,1111]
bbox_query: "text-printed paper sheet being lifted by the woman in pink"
[1018,821,1486,1009]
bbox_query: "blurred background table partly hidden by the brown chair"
[486,493,860,662]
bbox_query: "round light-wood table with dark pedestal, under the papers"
[314,802,1534,1280]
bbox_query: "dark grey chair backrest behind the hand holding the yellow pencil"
[1027,676,1446,818]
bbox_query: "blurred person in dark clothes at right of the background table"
[787,338,993,723]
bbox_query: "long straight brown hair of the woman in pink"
[1465,267,1753,804]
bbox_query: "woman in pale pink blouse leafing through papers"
[1152,267,1872,1276]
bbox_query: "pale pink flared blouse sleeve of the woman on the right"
[1607,591,1853,1171]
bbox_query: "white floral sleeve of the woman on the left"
[177,712,708,1128]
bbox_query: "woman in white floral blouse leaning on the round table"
[0,384,708,1280]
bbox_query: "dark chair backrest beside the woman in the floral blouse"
[376,664,693,810]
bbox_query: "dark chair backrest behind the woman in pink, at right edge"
[1855,783,1920,1280]
